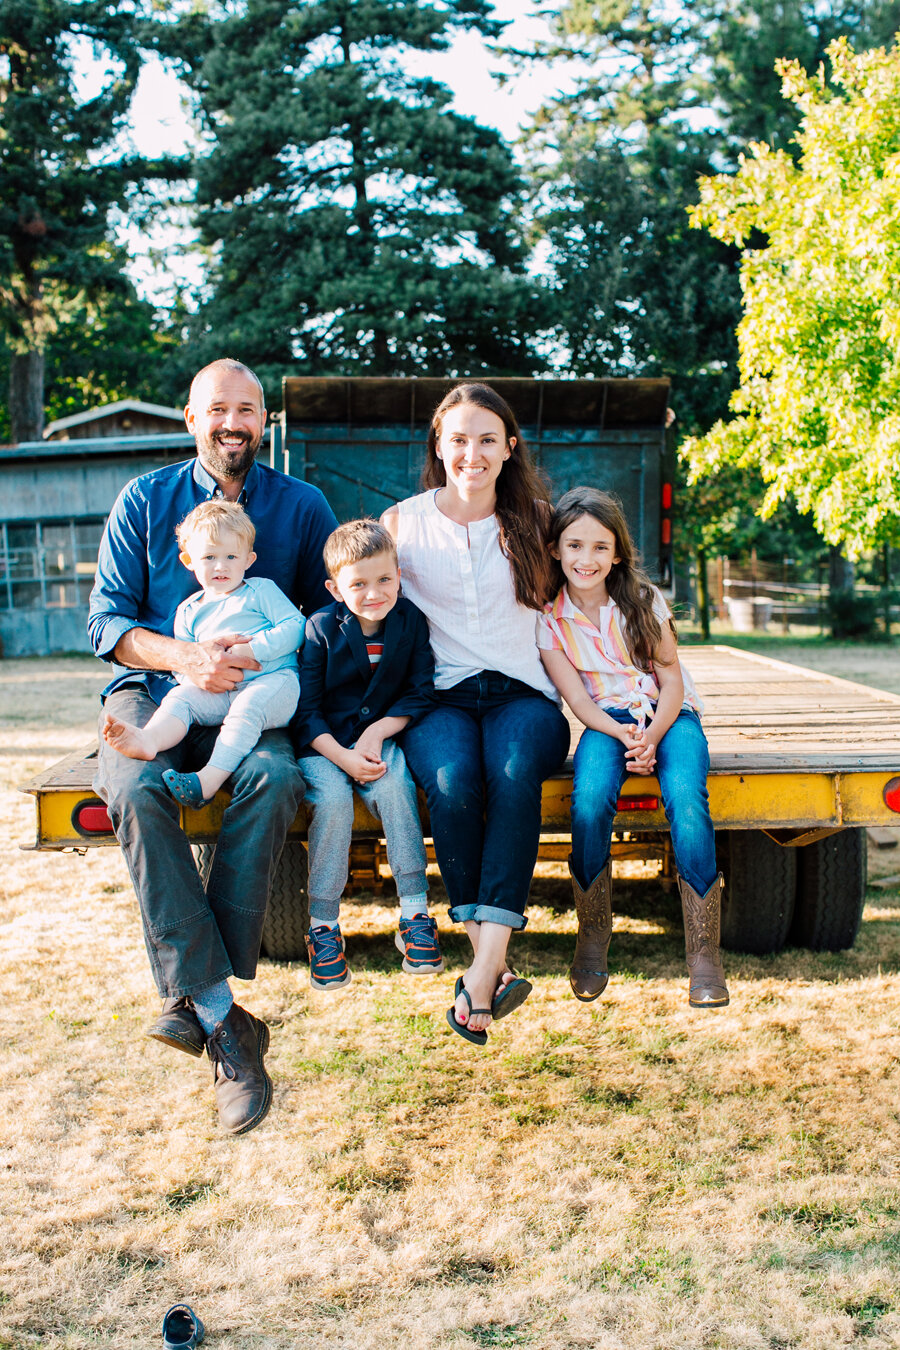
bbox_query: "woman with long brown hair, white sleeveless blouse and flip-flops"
[383,383,569,1045]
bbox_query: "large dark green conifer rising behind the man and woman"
[158,0,540,381]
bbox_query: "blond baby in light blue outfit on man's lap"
[103,498,304,809]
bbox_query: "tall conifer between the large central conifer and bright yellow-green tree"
[528,0,739,425]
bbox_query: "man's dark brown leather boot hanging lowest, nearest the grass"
[206,1003,271,1134]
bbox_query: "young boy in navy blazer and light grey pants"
[291,520,444,990]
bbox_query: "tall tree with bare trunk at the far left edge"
[0,0,175,440]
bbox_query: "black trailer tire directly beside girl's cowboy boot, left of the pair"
[715,830,797,956]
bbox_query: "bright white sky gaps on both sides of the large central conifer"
[120,0,577,304]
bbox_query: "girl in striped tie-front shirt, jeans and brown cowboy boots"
[537,487,729,1008]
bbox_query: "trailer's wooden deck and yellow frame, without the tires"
[23,645,900,849]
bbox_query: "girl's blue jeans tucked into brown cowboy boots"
[571,707,716,895]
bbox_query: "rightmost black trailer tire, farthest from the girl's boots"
[791,829,868,952]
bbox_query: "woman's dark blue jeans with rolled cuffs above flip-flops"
[402,671,569,929]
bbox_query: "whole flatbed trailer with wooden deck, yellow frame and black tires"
[23,645,900,960]
